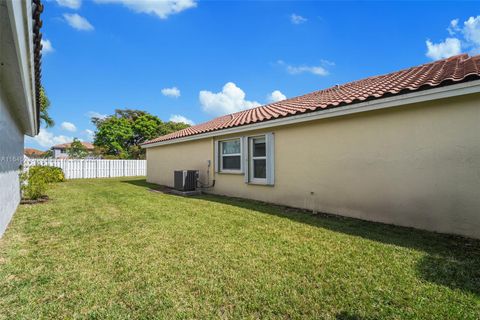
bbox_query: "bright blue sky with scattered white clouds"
[25,0,480,150]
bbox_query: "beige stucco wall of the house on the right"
[147,94,480,238]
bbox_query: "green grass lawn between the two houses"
[0,179,480,319]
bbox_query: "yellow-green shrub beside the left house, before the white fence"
[20,166,65,200]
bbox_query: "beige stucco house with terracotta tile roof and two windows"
[142,54,480,238]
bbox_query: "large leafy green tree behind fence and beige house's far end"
[92,109,188,159]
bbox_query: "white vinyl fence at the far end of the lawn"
[23,159,147,179]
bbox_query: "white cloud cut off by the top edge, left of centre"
[95,0,197,19]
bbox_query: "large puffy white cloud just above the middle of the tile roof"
[199,82,260,115]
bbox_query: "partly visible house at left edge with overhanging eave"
[0,0,43,236]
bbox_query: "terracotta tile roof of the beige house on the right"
[143,54,480,145]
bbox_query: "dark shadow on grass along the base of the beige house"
[123,180,480,296]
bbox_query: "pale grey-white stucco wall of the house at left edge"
[0,87,23,237]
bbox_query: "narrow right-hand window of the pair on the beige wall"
[249,136,267,183]
